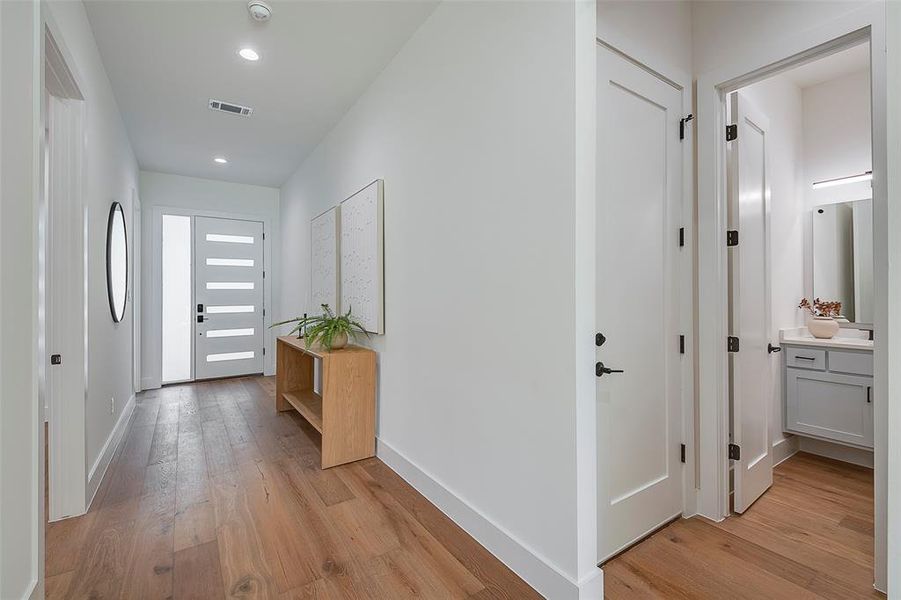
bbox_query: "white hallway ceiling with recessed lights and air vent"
[85,0,436,186]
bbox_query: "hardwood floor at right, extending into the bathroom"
[604,453,885,600]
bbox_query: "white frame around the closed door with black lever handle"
[591,37,698,552]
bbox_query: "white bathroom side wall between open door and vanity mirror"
[741,75,809,458]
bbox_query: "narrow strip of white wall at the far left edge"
[0,2,43,600]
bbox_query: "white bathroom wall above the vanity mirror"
[803,69,873,206]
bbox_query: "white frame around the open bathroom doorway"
[697,3,897,590]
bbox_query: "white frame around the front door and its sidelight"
[141,205,276,390]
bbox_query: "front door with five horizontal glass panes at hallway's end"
[194,217,265,379]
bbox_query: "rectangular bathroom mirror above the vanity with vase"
[813,200,873,323]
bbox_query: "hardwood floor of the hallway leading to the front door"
[46,377,540,600]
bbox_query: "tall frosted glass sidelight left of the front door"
[162,215,193,383]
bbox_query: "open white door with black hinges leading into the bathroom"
[727,92,773,513]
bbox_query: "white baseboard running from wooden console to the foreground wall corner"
[376,439,603,600]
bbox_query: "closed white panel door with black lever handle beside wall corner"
[597,47,683,561]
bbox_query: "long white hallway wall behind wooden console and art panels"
[279,2,597,598]
